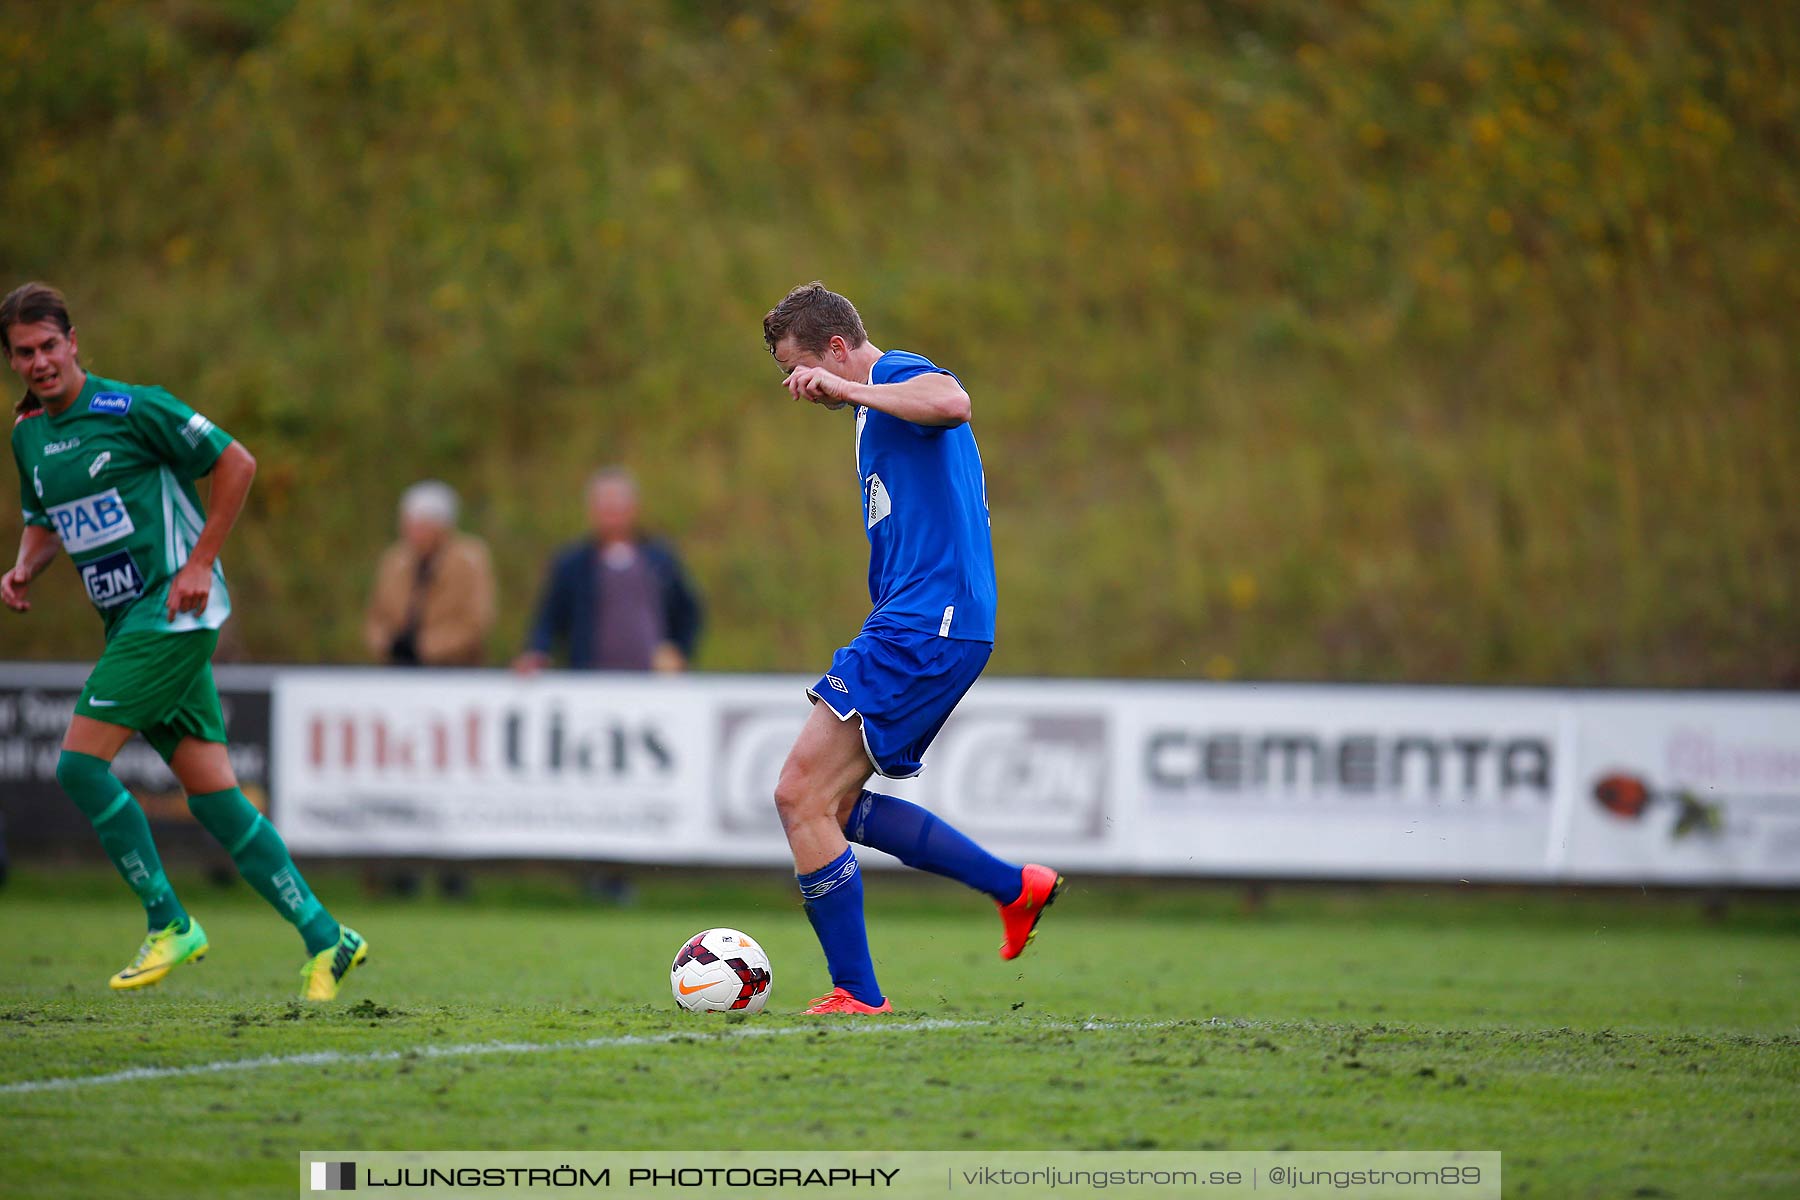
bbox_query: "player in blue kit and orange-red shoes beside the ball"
[763,282,1062,1013]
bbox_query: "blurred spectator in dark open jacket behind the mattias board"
[513,468,700,675]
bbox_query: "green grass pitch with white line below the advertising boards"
[0,874,1800,1196]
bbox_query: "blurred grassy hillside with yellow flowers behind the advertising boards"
[0,0,1800,685]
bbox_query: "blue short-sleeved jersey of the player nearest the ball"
[857,351,995,642]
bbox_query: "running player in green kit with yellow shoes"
[0,282,369,1000]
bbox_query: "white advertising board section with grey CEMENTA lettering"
[1118,685,1570,880]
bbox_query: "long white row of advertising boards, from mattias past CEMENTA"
[272,669,1800,885]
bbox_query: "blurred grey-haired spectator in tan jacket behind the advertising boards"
[362,479,493,667]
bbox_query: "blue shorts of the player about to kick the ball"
[806,630,994,779]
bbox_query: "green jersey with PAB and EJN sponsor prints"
[13,374,232,642]
